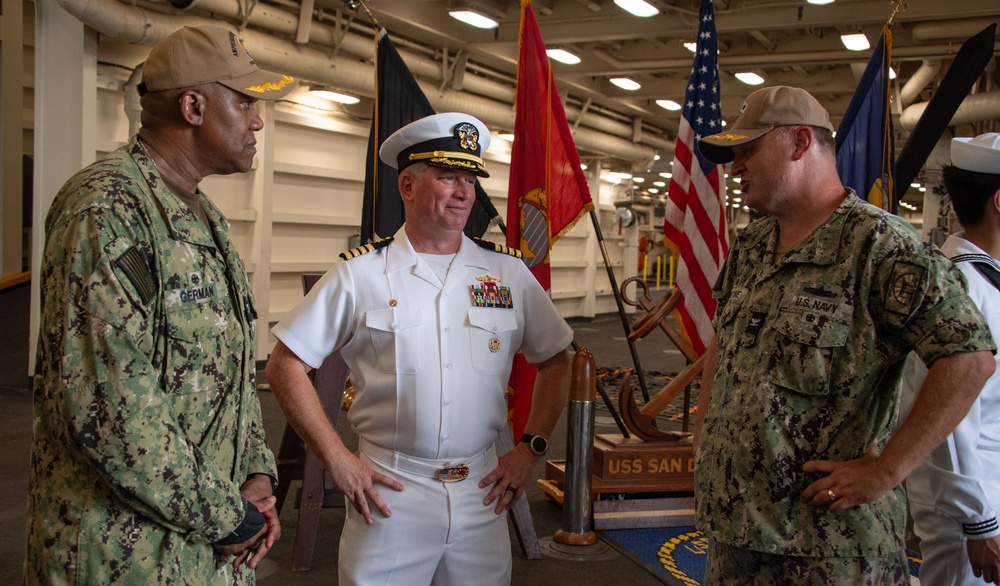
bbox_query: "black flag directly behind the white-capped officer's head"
[361,28,499,244]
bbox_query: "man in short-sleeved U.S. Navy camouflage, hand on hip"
[695,87,996,586]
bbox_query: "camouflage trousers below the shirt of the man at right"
[705,540,910,586]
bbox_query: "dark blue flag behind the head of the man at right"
[837,26,897,213]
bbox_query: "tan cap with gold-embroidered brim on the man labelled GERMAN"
[139,26,295,100]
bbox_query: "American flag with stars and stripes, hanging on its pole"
[663,0,729,354]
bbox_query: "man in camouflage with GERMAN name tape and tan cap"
[25,27,292,585]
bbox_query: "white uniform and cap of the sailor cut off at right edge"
[900,133,1000,586]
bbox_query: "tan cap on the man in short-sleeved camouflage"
[698,85,833,165]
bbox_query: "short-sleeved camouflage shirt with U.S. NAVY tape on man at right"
[695,192,995,557]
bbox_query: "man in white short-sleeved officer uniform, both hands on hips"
[267,113,573,585]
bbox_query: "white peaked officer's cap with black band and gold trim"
[378,112,490,177]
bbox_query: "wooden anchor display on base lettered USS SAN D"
[539,277,705,529]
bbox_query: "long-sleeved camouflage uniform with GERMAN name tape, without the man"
[25,138,276,586]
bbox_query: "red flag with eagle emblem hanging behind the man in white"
[507,0,594,438]
